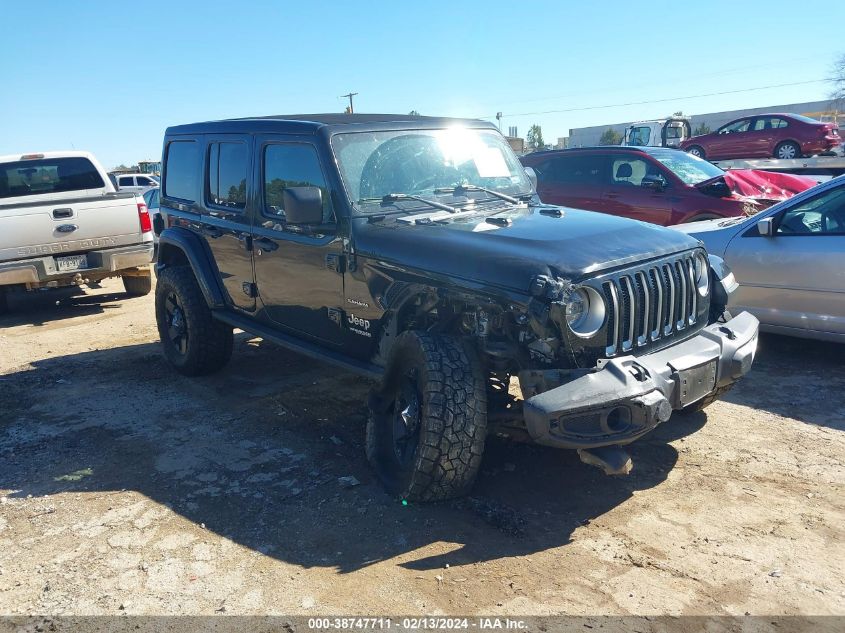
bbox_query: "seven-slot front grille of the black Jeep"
[601,253,700,357]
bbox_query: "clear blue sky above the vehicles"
[0,0,845,168]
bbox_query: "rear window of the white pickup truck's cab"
[0,156,105,198]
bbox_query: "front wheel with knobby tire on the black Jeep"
[366,332,487,501]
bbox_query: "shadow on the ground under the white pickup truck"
[0,286,131,328]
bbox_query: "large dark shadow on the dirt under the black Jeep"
[0,335,684,572]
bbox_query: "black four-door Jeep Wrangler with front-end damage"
[156,115,757,500]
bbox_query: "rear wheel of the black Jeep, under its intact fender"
[156,266,233,376]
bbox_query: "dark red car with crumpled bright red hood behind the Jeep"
[520,146,816,226]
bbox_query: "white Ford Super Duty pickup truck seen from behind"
[0,152,153,312]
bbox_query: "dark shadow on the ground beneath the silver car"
[722,333,845,431]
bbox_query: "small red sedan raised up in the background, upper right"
[680,114,842,160]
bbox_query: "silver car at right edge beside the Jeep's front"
[672,175,845,342]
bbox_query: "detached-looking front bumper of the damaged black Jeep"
[524,312,759,448]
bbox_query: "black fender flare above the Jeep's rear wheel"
[156,226,226,309]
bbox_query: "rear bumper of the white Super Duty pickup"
[0,242,153,287]
